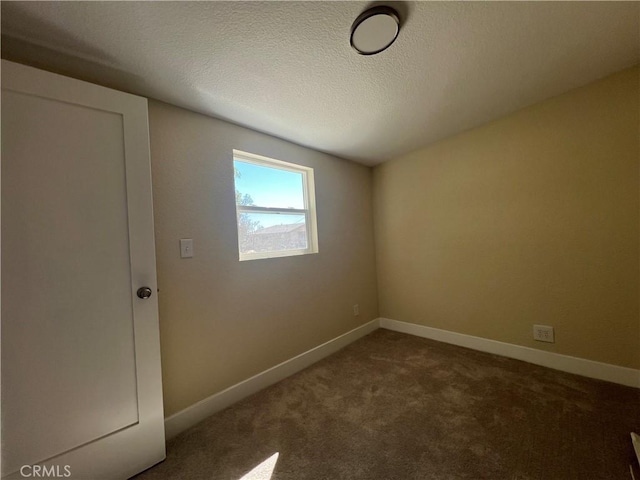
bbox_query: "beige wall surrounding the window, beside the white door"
[149,100,378,415]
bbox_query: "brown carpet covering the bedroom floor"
[136,330,640,480]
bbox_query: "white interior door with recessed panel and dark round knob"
[1,61,165,479]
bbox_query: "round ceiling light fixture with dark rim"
[351,5,400,55]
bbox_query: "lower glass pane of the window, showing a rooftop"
[238,213,308,253]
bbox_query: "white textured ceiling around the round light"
[1,1,640,165]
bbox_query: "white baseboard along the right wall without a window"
[379,318,640,388]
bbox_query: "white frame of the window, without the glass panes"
[233,149,318,262]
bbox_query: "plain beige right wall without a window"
[374,68,640,368]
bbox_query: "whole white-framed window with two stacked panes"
[233,150,318,260]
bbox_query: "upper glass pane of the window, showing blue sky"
[233,160,304,209]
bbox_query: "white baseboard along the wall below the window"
[164,319,379,440]
